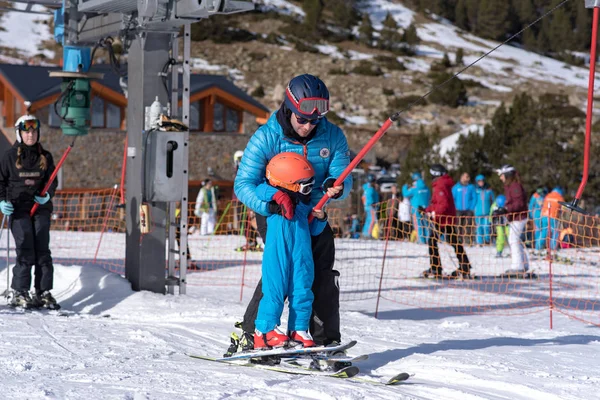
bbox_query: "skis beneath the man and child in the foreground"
[188,340,410,385]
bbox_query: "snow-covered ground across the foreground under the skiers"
[0,232,600,400]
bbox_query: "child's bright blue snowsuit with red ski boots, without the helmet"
[254,153,327,349]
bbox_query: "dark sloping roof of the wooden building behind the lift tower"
[0,64,269,112]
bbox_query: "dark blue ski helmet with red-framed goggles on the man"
[284,74,329,119]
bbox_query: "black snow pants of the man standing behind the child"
[242,214,341,345]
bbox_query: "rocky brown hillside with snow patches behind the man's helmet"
[0,0,588,162]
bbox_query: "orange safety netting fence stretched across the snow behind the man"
[2,189,600,325]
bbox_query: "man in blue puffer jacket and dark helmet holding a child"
[227,74,352,353]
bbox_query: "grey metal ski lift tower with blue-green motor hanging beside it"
[13,0,254,294]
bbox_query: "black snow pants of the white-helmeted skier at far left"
[10,208,54,292]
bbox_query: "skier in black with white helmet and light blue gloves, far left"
[0,114,60,309]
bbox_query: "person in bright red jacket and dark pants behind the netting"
[423,164,471,279]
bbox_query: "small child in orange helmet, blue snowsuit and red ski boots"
[254,152,327,349]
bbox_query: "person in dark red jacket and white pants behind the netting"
[496,164,529,273]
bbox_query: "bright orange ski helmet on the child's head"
[267,152,315,195]
